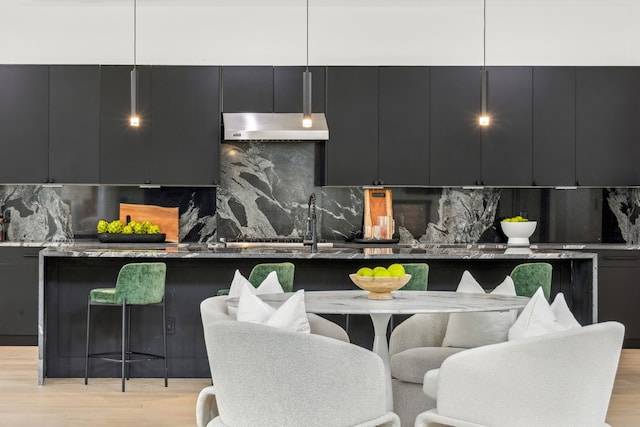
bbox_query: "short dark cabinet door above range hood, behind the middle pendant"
[273,67,325,113]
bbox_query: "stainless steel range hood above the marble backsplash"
[222,113,329,141]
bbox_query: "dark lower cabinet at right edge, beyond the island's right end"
[598,251,640,348]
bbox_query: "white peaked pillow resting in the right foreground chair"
[509,288,580,341]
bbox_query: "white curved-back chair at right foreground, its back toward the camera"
[415,322,624,427]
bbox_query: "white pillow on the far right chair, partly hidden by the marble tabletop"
[442,271,517,348]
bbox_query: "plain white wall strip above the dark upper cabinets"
[0,0,640,65]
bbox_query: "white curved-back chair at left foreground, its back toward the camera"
[196,320,400,427]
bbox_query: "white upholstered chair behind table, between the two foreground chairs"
[389,313,466,427]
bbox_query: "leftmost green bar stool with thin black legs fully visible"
[84,262,168,392]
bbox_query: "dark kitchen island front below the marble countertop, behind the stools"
[41,255,593,378]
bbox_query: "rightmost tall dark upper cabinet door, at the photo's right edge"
[576,67,640,186]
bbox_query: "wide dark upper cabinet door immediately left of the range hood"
[148,66,221,185]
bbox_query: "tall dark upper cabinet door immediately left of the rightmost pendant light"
[429,67,481,187]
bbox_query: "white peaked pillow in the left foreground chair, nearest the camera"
[237,284,311,333]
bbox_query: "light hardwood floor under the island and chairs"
[0,347,640,427]
